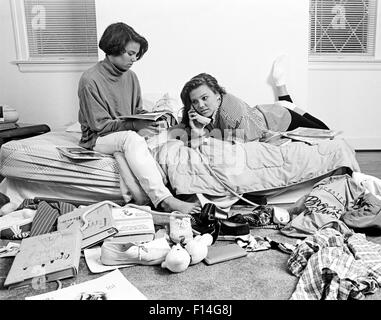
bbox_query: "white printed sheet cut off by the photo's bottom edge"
[25,270,147,300]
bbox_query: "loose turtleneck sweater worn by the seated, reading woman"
[78,57,142,149]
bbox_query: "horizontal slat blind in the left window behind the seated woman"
[24,0,98,60]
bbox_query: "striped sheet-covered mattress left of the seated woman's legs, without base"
[0,131,120,189]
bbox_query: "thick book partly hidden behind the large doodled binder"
[57,200,118,249]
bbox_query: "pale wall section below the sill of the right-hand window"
[308,64,381,149]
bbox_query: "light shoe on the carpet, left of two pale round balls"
[101,238,171,266]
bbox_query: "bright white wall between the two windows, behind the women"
[96,0,308,109]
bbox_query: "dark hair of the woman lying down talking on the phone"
[180,73,226,126]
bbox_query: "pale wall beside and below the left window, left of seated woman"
[0,0,81,129]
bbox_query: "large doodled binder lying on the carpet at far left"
[4,223,82,289]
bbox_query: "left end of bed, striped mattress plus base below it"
[0,131,127,203]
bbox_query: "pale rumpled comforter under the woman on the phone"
[153,138,360,196]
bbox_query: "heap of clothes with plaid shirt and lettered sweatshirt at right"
[281,173,381,300]
